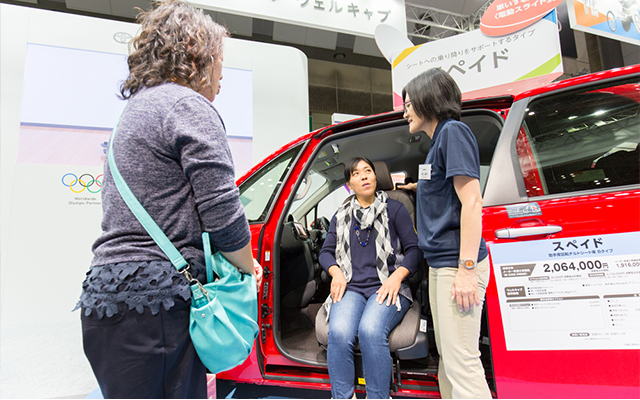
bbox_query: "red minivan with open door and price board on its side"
[217,65,640,398]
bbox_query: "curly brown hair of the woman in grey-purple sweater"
[120,0,229,99]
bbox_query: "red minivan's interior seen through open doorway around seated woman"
[273,110,503,388]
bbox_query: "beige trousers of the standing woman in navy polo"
[429,257,491,399]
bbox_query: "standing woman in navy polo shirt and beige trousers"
[402,68,491,399]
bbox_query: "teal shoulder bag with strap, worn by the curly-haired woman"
[108,125,259,374]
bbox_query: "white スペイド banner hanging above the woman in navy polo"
[392,10,563,106]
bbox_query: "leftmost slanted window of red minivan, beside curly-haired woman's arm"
[239,146,302,223]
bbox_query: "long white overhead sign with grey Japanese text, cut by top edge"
[190,0,407,38]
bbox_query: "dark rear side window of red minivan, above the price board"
[518,78,640,197]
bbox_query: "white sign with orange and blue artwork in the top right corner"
[567,0,640,46]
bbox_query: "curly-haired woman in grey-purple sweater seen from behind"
[78,1,261,398]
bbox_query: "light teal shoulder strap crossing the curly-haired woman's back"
[108,119,188,272]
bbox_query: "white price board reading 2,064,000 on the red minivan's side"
[490,232,640,350]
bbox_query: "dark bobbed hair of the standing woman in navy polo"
[402,68,462,121]
